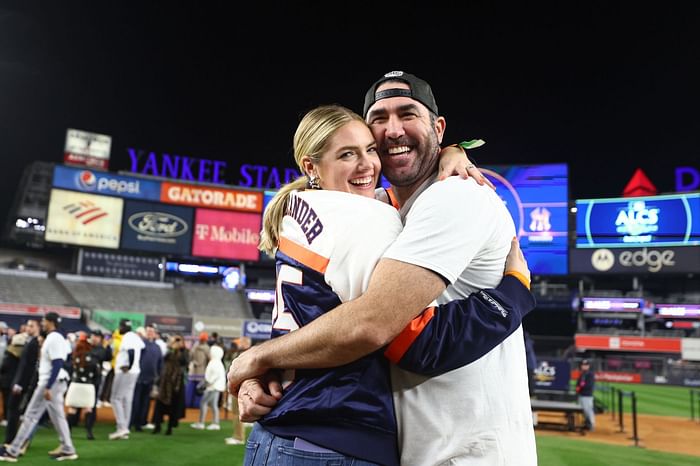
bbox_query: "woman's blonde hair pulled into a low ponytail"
[258,105,365,256]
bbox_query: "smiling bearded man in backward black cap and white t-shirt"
[229,72,537,465]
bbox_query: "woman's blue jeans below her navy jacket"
[244,423,377,466]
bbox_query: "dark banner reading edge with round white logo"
[569,246,700,274]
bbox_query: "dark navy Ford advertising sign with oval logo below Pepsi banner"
[121,201,194,256]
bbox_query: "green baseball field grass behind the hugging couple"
[5,383,700,466]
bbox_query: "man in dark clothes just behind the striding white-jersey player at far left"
[5,319,39,444]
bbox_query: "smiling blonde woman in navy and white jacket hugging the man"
[239,106,529,465]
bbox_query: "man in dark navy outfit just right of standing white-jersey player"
[131,325,163,432]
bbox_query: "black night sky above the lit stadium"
[0,1,700,224]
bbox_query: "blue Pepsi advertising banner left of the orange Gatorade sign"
[53,165,160,201]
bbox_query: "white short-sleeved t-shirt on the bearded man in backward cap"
[384,177,537,466]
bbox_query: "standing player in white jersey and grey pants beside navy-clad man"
[109,319,145,440]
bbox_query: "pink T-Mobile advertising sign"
[192,209,260,261]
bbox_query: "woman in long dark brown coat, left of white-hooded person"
[153,335,189,435]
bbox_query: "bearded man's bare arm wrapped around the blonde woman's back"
[228,259,445,394]
